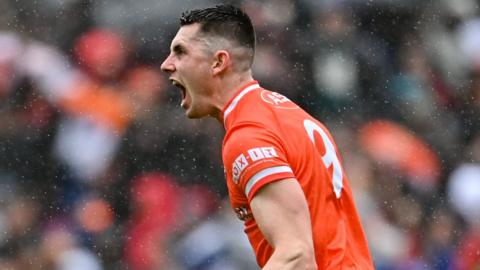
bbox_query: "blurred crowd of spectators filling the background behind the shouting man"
[0,0,480,270]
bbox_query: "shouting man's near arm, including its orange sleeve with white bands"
[223,126,316,269]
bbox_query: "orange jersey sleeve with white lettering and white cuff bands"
[223,125,295,201]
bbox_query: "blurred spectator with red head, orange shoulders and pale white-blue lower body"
[52,30,132,186]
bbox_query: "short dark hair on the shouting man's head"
[180,5,255,51]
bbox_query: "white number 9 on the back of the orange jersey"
[303,119,343,198]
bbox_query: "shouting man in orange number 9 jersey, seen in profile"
[161,5,373,269]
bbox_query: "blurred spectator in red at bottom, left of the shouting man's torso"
[125,173,182,270]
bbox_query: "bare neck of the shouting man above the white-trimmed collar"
[211,71,253,123]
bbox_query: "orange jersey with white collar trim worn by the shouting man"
[223,81,373,270]
